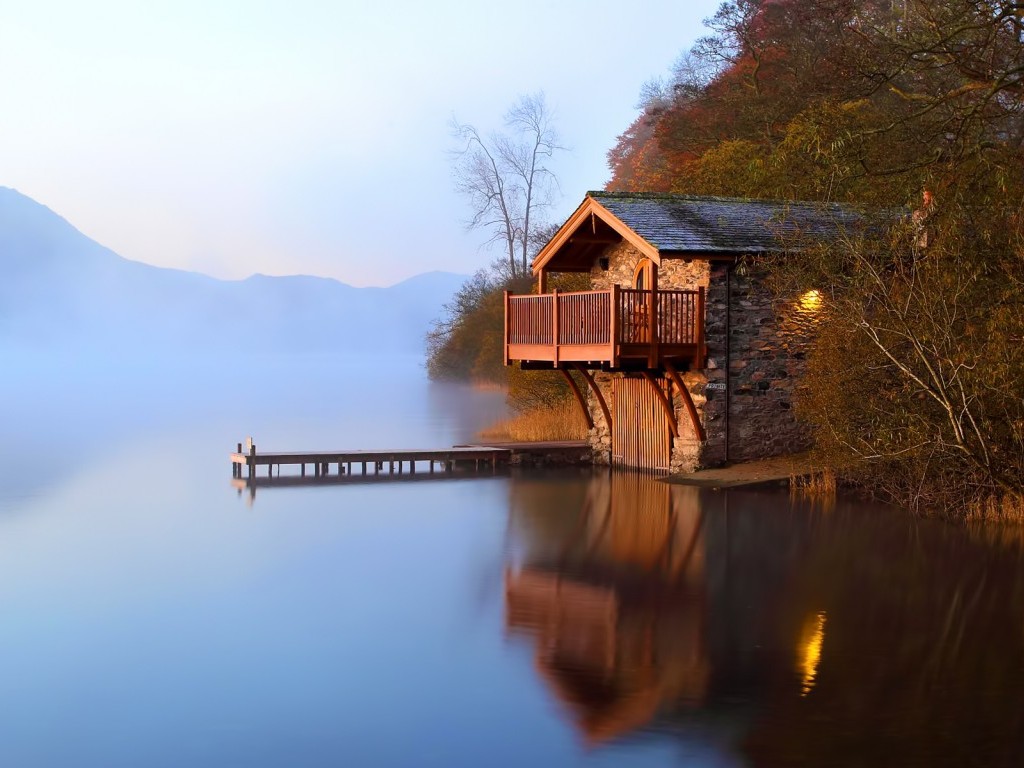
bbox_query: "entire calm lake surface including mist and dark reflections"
[0,356,1024,768]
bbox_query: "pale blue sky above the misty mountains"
[0,0,718,285]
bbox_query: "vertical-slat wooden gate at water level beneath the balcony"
[611,376,672,472]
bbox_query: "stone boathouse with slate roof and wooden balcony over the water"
[505,191,858,472]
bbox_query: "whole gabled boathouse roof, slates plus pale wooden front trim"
[534,191,861,272]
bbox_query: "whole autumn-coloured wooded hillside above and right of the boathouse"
[434,0,1024,518]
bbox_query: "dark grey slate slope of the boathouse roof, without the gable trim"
[588,191,862,253]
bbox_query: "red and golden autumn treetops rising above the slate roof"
[609,0,1024,204]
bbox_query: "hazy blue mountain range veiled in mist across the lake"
[0,187,465,352]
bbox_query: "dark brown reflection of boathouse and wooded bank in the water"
[505,474,1024,766]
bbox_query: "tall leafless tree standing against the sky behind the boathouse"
[452,93,565,278]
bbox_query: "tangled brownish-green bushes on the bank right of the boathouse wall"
[774,185,1024,516]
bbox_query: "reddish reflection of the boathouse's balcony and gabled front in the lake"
[505,473,711,742]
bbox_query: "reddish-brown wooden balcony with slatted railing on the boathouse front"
[505,286,705,370]
